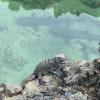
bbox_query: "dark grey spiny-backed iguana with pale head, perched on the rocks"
[21,54,66,89]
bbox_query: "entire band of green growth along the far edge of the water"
[2,0,100,17]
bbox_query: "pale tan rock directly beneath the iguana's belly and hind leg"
[23,76,61,97]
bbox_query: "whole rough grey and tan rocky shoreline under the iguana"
[0,54,100,100]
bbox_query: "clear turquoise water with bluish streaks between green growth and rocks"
[0,2,100,84]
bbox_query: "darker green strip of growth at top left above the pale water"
[2,0,61,11]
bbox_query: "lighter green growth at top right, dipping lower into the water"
[54,0,100,17]
